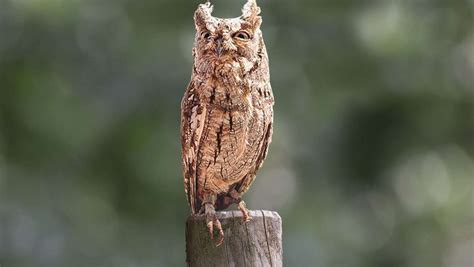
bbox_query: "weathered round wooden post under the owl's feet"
[186,210,283,267]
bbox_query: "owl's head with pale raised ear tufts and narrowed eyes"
[193,0,264,75]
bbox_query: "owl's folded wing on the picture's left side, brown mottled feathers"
[181,83,207,214]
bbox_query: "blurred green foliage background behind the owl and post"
[0,0,474,267]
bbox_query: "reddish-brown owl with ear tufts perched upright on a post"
[181,0,274,245]
